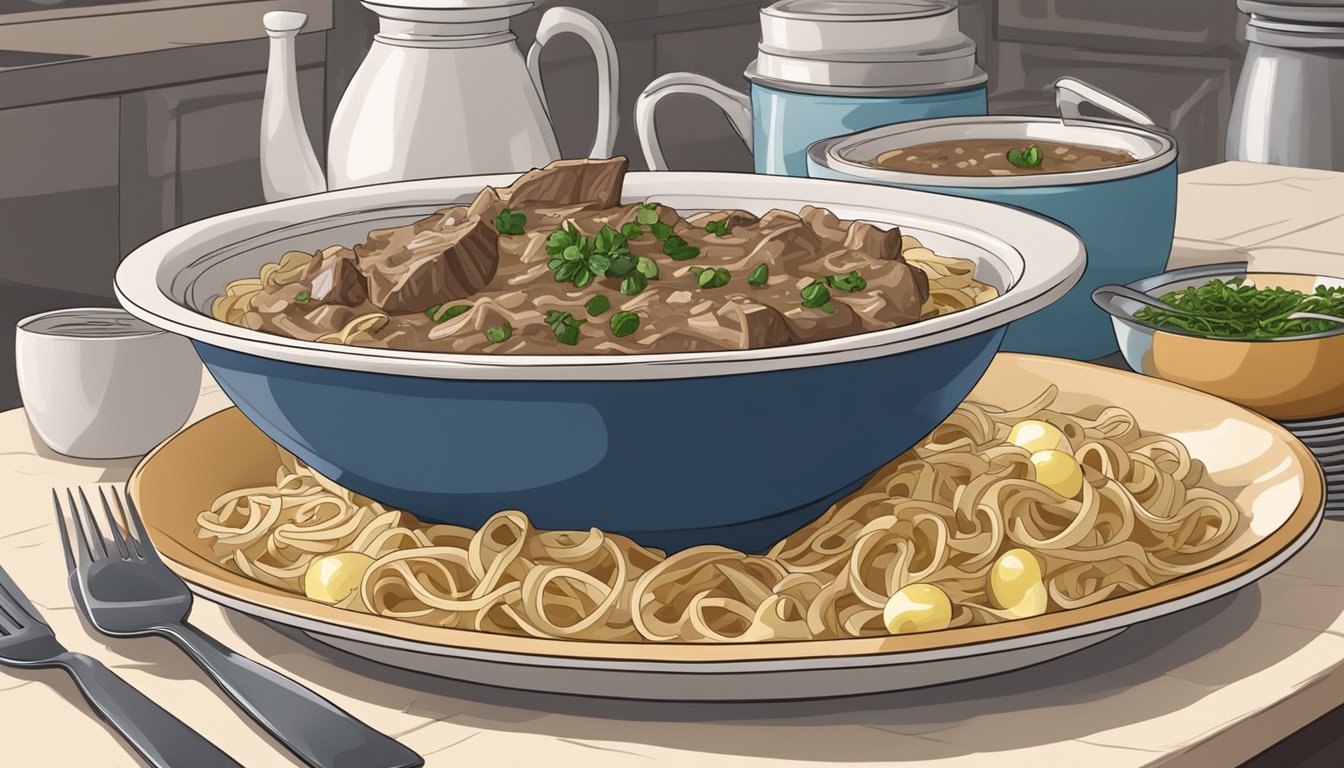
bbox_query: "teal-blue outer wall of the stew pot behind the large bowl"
[808,159,1176,360]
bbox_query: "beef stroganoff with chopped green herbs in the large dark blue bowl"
[211,157,997,355]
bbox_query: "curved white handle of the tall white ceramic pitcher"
[527,7,621,159]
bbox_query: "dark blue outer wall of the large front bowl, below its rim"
[194,327,1004,551]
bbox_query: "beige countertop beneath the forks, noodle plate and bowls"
[0,164,1344,768]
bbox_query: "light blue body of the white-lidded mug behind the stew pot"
[751,83,989,176]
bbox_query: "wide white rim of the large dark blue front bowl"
[114,172,1086,381]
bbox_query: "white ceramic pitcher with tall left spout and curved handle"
[261,0,618,200]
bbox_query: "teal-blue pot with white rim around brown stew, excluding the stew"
[808,116,1176,360]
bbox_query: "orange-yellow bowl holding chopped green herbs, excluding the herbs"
[1102,262,1344,421]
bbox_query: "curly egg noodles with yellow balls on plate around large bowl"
[199,387,1242,642]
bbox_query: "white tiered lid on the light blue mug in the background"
[749,0,982,89]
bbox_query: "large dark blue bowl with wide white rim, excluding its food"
[117,174,1085,551]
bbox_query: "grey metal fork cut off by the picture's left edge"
[0,568,242,768]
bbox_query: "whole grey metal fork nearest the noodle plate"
[51,488,425,768]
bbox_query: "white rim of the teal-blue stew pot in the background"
[808,114,1177,190]
